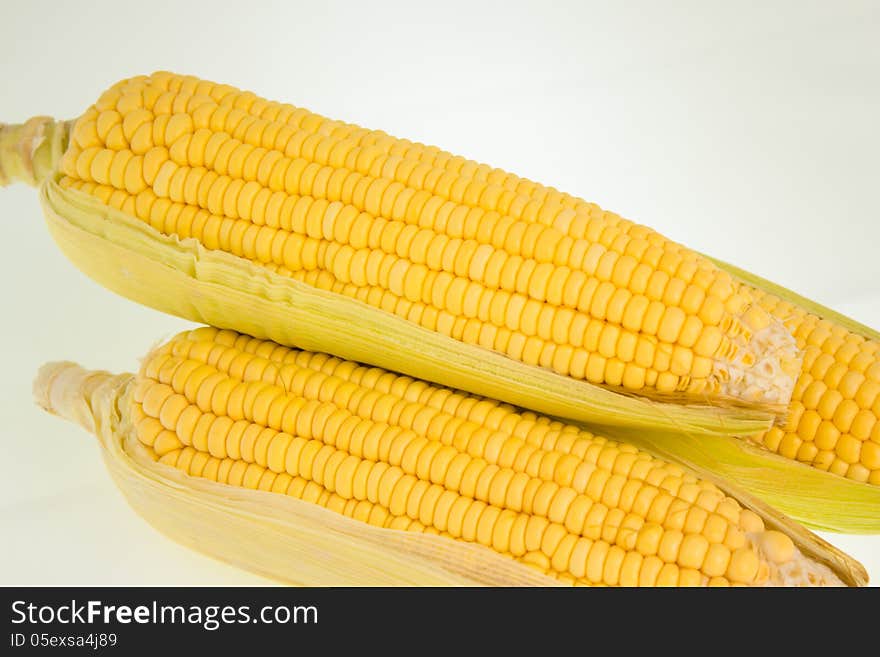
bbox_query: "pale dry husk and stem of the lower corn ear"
[34,362,558,586]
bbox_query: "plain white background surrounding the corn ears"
[0,0,880,584]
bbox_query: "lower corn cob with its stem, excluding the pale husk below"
[36,328,865,586]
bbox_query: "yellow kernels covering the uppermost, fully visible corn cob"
[61,73,784,402]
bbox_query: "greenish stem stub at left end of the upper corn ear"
[0,116,73,187]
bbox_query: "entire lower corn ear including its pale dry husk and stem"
[35,329,866,585]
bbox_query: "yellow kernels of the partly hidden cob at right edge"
[754,290,880,484]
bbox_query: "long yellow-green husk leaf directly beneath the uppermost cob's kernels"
[40,180,773,435]
